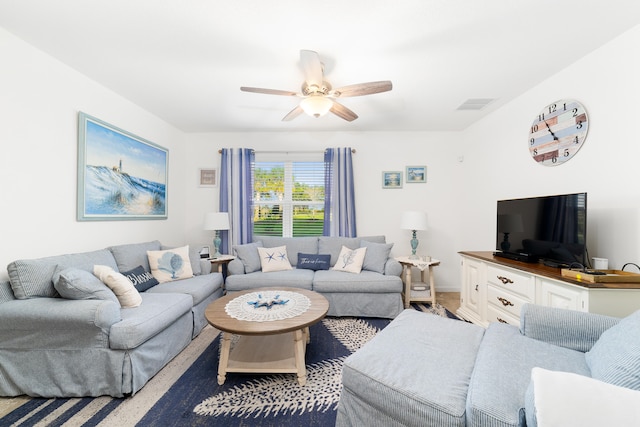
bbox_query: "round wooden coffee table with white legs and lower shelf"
[205,287,329,385]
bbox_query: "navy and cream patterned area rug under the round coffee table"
[0,304,457,427]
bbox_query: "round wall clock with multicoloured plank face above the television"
[529,99,589,166]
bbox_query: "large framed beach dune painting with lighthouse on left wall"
[78,112,169,221]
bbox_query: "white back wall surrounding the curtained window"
[185,132,462,290]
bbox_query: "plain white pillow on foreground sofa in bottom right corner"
[531,368,640,427]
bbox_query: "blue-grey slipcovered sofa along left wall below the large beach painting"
[0,241,223,397]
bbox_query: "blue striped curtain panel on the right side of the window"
[323,148,356,237]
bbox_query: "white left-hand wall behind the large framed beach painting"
[0,28,186,280]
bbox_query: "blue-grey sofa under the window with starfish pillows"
[225,236,404,318]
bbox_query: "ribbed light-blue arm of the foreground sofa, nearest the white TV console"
[520,304,620,352]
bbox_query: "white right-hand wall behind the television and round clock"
[458,26,640,271]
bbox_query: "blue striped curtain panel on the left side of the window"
[220,148,255,254]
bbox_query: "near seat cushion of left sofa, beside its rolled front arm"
[109,292,193,350]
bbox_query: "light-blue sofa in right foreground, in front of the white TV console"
[336,305,640,427]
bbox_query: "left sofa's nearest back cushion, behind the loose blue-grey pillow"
[7,249,118,299]
